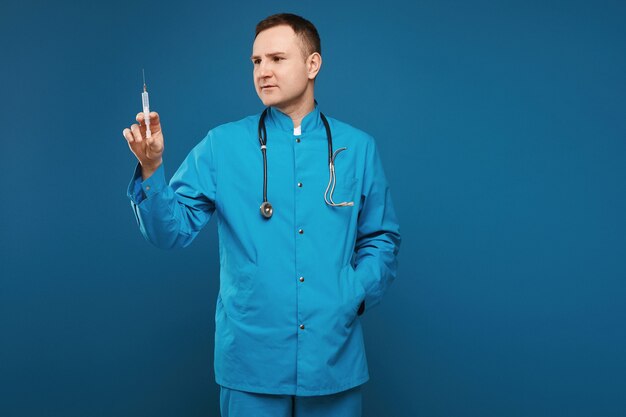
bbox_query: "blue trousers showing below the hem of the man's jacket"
[220,386,361,417]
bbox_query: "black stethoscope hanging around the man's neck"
[259,107,354,219]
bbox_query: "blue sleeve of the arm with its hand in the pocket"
[355,138,401,314]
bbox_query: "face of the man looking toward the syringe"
[251,25,321,110]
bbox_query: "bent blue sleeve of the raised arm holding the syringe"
[127,132,216,249]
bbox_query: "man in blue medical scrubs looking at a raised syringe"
[123,14,400,417]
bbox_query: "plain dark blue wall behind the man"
[0,1,626,417]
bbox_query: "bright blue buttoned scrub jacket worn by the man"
[128,101,400,396]
